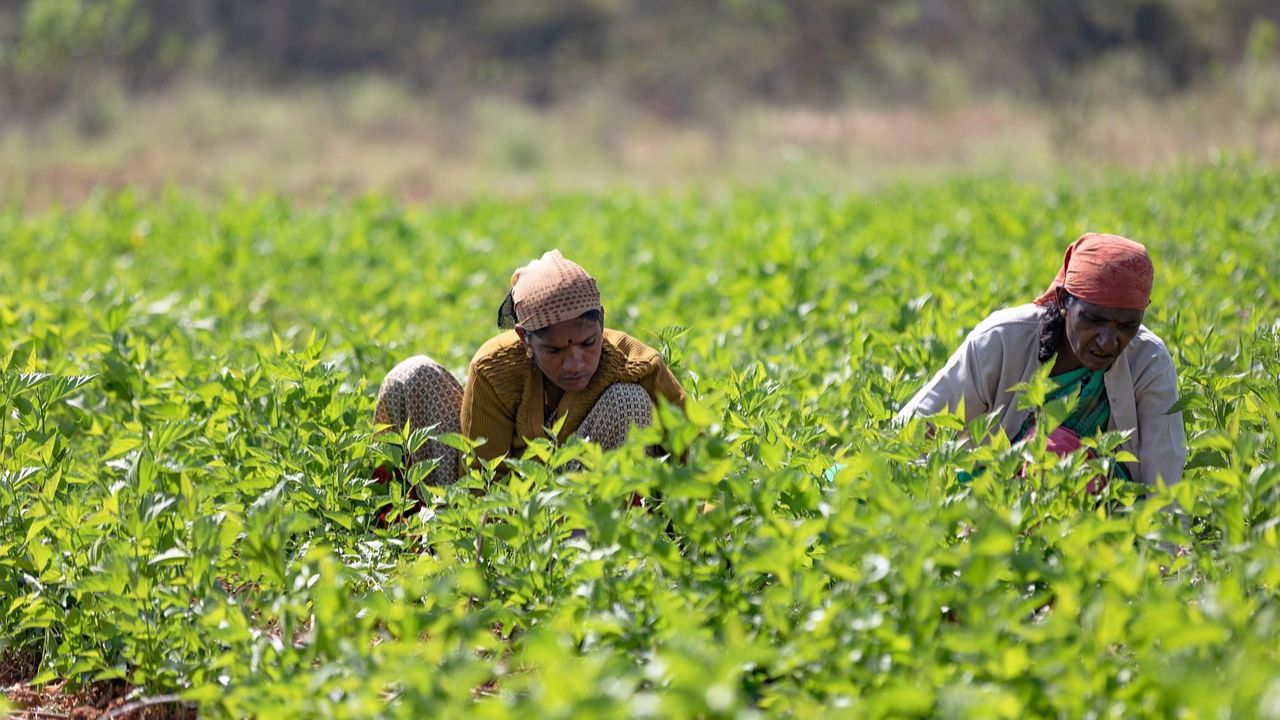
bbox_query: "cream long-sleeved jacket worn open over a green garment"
[897,305,1187,484]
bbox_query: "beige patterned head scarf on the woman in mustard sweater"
[511,250,600,332]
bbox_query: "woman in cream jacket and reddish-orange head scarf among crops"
[899,233,1187,484]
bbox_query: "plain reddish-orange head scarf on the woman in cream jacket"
[1036,232,1156,310]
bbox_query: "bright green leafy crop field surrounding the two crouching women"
[0,161,1280,719]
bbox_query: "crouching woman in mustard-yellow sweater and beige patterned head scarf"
[374,250,685,484]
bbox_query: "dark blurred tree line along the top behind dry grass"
[0,0,1280,117]
